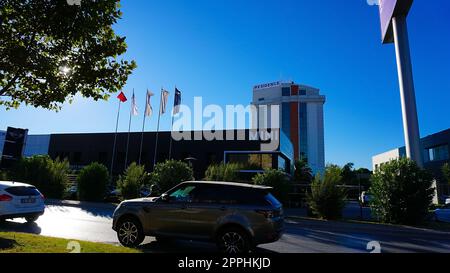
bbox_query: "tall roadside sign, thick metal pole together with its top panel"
[380,0,423,167]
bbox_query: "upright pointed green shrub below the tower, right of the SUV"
[306,166,346,220]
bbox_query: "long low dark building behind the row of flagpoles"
[48,130,293,179]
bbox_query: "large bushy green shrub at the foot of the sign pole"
[370,158,434,224]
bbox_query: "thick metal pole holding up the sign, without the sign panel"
[392,15,423,168]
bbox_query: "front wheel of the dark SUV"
[117,217,145,247]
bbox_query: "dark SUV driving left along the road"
[113,182,284,253]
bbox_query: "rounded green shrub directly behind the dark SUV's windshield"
[151,160,194,192]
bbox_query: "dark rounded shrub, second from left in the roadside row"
[77,163,109,202]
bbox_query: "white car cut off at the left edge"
[0,181,45,223]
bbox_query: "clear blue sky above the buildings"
[0,0,450,167]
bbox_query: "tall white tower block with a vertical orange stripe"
[252,81,326,173]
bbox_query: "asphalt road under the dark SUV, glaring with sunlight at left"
[0,206,450,253]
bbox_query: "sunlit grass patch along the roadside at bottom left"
[0,232,142,253]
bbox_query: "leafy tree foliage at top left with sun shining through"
[0,0,136,110]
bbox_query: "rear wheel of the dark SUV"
[217,227,251,254]
